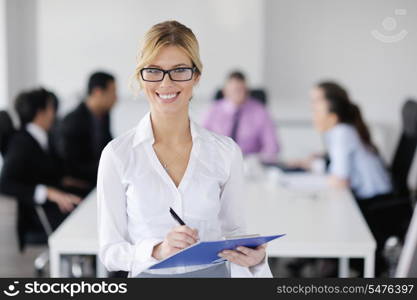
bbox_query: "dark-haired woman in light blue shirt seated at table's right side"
[292,82,393,275]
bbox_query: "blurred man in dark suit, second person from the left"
[59,72,117,194]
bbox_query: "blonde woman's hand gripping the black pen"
[152,225,199,260]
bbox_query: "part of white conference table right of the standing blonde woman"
[246,174,376,277]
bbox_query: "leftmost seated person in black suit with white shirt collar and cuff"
[0,88,83,249]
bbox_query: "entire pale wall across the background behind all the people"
[3,0,417,183]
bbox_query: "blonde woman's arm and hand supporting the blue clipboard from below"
[219,144,272,277]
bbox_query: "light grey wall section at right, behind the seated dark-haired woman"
[265,0,417,158]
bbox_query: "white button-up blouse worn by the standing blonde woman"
[97,113,272,277]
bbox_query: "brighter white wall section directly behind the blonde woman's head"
[37,0,264,131]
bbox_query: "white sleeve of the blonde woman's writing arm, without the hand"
[97,144,161,276]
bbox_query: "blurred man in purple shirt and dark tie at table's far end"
[203,72,279,162]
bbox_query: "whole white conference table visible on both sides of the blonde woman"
[49,175,376,277]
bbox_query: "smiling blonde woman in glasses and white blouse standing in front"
[97,21,271,277]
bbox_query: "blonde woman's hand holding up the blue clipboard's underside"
[219,244,266,267]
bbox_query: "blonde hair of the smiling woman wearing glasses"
[134,21,203,88]
